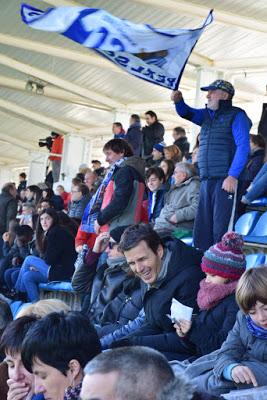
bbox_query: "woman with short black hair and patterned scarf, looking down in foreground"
[22,311,101,400]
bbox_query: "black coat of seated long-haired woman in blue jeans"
[42,226,77,281]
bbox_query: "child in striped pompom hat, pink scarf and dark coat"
[174,232,246,356]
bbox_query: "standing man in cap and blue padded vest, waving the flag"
[171,79,252,250]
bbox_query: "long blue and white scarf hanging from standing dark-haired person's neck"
[80,157,127,233]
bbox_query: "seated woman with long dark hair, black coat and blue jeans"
[15,208,76,302]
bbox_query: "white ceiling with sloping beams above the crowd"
[0,0,267,168]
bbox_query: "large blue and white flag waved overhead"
[21,4,213,89]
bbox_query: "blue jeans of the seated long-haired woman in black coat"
[15,256,49,302]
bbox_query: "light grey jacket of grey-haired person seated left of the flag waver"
[154,176,200,231]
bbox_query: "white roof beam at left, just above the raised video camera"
[0,98,77,133]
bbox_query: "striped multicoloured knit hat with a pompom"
[201,232,246,280]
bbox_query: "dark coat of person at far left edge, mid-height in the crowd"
[0,192,18,236]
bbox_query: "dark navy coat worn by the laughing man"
[140,239,204,332]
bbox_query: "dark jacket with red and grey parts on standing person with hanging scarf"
[97,156,145,230]
